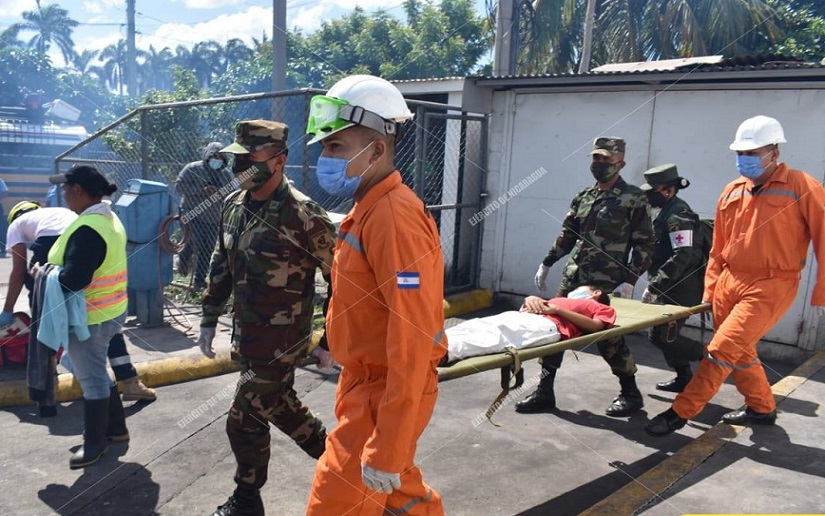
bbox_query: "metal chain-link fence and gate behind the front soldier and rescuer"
[55,90,487,300]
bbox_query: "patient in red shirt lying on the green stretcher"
[439,285,616,366]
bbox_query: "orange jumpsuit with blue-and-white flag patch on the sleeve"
[307,171,447,516]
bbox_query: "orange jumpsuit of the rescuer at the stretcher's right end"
[673,163,825,419]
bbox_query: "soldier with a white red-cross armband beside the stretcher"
[642,164,707,392]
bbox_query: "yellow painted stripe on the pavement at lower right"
[581,351,825,516]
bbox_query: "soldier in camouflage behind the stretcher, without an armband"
[516,137,653,417]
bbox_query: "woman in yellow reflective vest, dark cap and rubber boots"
[38,165,129,469]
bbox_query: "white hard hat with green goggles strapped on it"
[307,75,413,145]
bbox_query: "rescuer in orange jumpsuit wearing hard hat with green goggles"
[307,75,447,516]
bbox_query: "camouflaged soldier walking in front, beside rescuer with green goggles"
[198,120,335,516]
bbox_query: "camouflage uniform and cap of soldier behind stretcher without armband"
[539,138,653,406]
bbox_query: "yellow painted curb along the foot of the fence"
[0,289,493,407]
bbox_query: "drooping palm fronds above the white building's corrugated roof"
[519,0,781,73]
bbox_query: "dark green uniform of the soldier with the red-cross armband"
[647,167,706,371]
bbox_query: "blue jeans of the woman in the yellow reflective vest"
[64,314,126,400]
